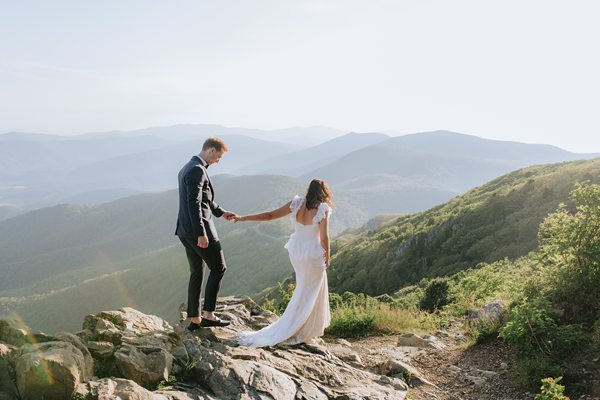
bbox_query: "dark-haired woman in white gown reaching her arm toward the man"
[236,179,333,347]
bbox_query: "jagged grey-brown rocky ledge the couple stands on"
[0,297,410,400]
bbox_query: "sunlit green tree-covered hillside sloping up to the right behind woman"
[330,159,600,295]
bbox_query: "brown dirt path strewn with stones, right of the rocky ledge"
[328,334,534,400]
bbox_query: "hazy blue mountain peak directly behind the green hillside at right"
[302,131,599,193]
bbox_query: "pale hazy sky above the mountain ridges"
[0,0,600,152]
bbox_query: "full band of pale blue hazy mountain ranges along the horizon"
[0,125,594,216]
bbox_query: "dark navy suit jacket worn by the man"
[175,156,225,242]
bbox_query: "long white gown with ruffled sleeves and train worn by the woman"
[237,196,331,347]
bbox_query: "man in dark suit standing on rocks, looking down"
[175,137,237,331]
